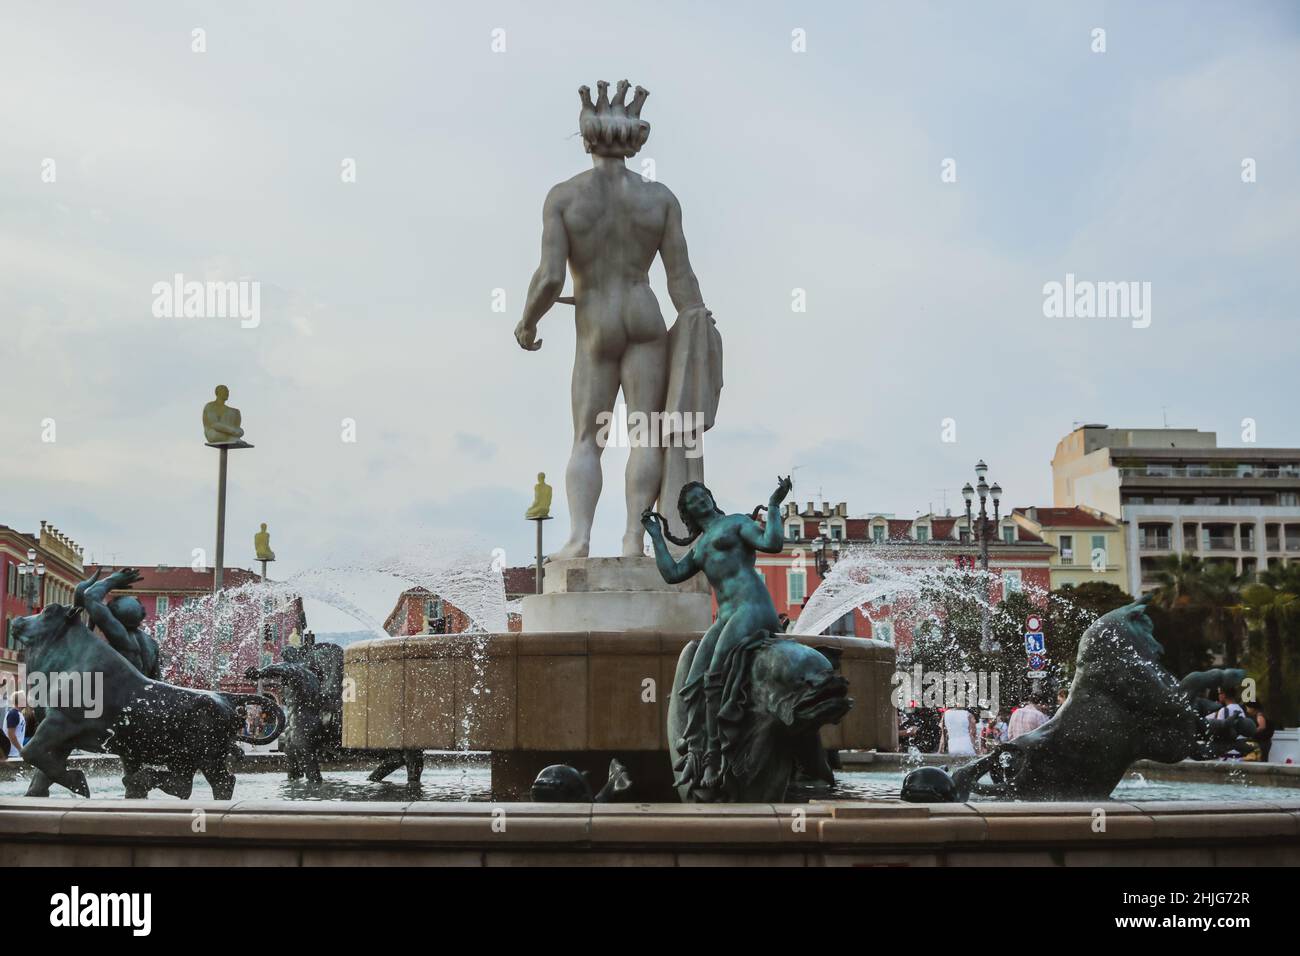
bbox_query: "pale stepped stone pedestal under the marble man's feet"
[523,558,714,633]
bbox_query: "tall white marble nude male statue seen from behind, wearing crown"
[515,79,722,558]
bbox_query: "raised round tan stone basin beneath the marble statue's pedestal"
[343,631,898,800]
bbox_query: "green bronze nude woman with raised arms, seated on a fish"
[641,477,790,791]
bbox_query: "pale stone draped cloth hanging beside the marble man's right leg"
[659,307,723,537]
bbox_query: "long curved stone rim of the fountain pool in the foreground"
[0,799,1300,866]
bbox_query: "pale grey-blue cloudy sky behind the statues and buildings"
[0,1,1300,630]
